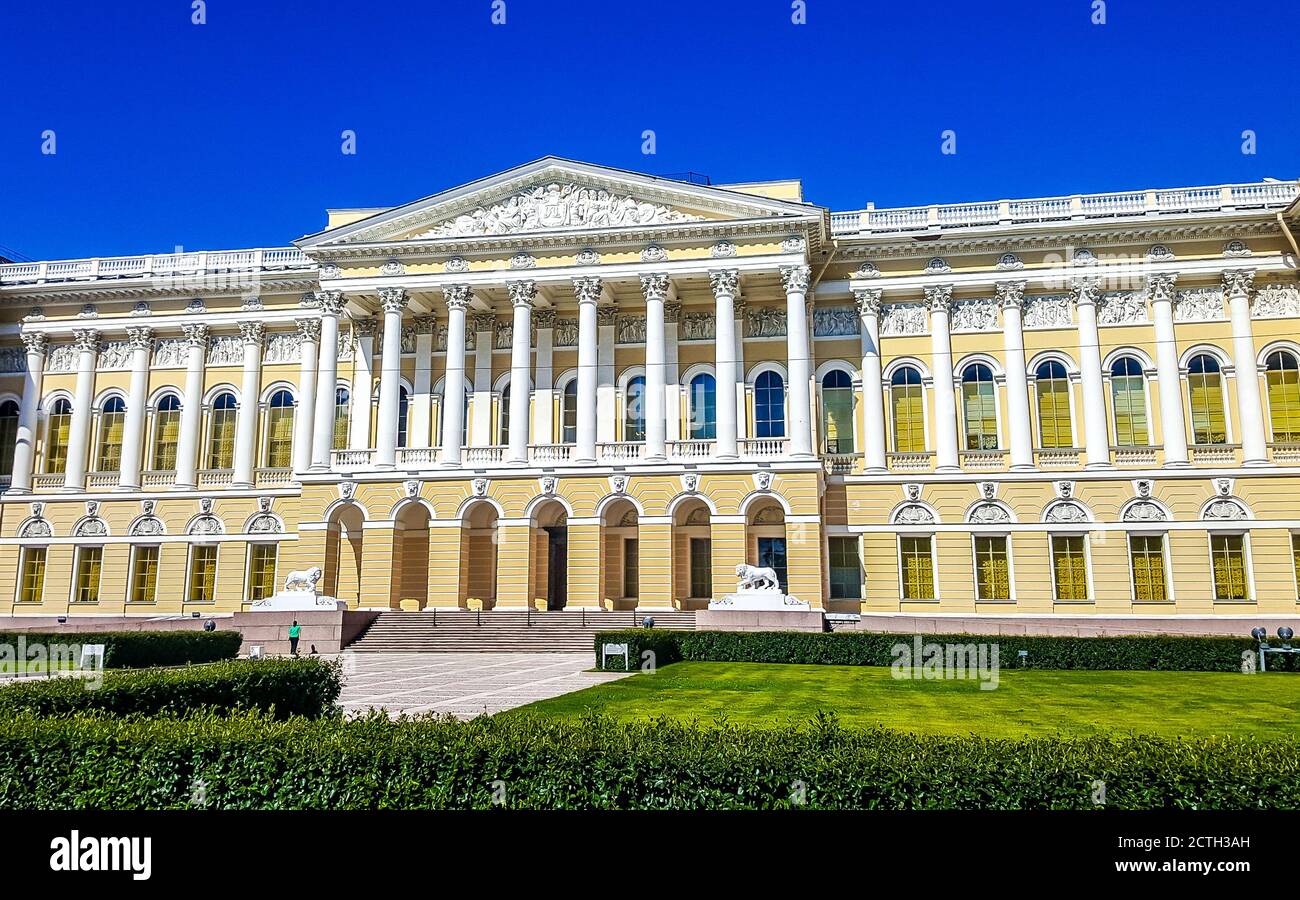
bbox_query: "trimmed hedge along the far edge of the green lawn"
[595,628,1296,672]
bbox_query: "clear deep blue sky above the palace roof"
[0,0,1300,259]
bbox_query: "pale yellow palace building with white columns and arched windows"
[0,157,1300,616]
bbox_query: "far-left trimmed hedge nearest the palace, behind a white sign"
[0,631,243,668]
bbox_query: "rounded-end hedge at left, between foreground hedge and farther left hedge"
[0,658,341,718]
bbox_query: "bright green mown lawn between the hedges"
[507,662,1300,737]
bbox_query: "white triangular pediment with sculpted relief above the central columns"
[298,157,818,247]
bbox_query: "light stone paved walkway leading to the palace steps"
[339,652,627,719]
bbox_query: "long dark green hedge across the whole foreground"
[0,713,1300,810]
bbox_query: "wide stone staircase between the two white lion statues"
[347,610,696,653]
